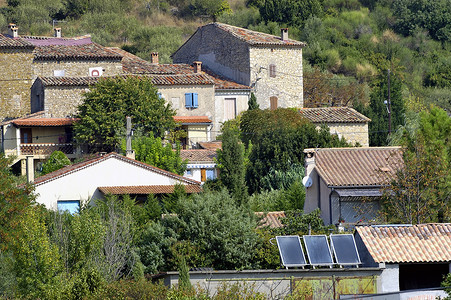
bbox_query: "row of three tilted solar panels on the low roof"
[276,234,361,268]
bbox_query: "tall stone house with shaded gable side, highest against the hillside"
[172,23,305,109]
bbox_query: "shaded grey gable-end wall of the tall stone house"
[173,24,250,85]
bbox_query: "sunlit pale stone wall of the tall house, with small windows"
[249,47,304,109]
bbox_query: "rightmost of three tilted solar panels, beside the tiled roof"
[330,234,361,265]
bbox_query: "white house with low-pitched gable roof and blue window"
[34,153,200,212]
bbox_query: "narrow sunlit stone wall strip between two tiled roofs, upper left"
[32,60,122,79]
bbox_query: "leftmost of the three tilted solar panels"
[276,235,307,268]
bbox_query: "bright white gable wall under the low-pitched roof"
[35,157,191,209]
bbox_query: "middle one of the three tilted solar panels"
[303,235,334,266]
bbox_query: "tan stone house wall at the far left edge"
[0,49,33,121]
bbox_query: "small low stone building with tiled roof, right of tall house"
[299,107,371,147]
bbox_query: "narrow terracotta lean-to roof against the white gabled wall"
[98,184,202,195]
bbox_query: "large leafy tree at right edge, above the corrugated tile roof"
[384,107,451,224]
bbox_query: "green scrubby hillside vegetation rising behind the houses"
[0,0,451,116]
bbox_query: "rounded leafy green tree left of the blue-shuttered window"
[74,77,175,151]
